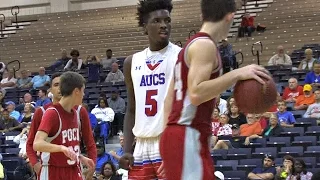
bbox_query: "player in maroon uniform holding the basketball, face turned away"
[160,0,271,180]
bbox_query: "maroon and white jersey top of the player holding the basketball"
[168,32,222,135]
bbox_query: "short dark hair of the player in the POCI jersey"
[60,71,86,96]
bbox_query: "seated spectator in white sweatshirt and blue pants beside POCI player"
[91,98,115,142]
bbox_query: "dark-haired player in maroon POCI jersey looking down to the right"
[33,72,94,180]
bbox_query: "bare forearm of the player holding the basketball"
[189,69,239,106]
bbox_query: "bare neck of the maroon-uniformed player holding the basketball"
[200,22,225,44]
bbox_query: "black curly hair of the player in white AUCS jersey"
[137,0,173,27]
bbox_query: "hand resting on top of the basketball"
[236,64,272,84]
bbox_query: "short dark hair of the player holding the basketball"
[201,0,237,22]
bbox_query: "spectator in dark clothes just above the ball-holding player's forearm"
[219,39,236,73]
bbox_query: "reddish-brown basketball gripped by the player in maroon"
[234,79,277,113]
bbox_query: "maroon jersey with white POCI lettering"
[38,104,80,167]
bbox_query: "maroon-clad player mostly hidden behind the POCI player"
[26,73,97,179]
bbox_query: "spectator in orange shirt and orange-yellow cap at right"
[294,84,315,110]
